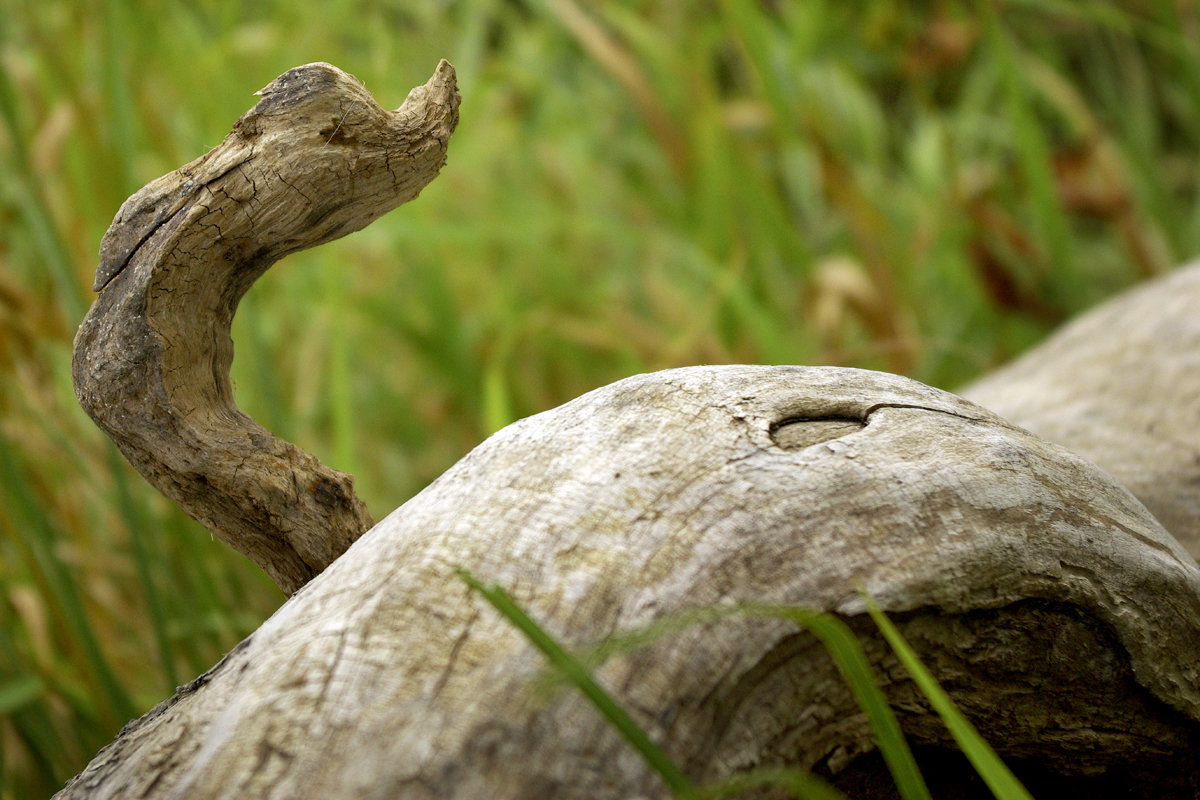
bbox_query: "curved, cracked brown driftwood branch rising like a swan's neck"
[72,61,460,594]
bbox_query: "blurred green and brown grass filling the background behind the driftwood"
[0,0,1200,798]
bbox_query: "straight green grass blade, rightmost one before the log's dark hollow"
[863,595,1032,800]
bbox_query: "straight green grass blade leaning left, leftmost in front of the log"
[458,570,700,799]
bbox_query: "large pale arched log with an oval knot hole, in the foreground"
[59,59,1200,799]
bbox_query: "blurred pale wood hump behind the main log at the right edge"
[961,264,1200,558]
